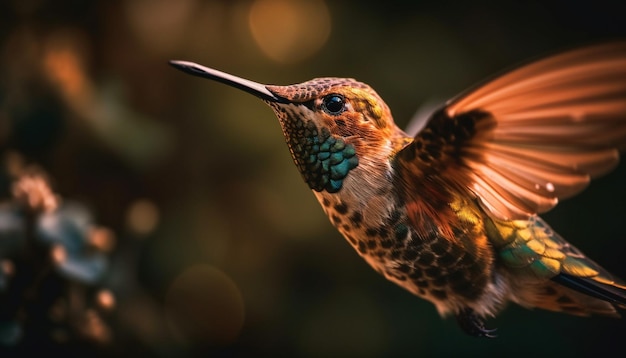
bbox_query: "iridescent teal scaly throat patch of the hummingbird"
[272,105,359,193]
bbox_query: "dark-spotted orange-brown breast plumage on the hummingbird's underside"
[320,194,488,302]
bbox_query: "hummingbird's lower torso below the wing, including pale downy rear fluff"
[316,182,500,315]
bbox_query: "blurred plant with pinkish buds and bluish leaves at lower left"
[0,159,115,353]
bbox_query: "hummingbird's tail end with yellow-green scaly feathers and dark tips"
[490,217,626,317]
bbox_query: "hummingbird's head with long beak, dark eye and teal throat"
[170,61,407,193]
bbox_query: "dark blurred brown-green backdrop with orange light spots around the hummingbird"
[0,0,626,357]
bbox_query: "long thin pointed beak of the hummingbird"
[170,61,287,103]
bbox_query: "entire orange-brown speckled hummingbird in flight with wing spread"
[170,42,626,337]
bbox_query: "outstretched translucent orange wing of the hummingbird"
[400,43,626,219]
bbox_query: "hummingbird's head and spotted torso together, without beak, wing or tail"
[269,87,504,314]
